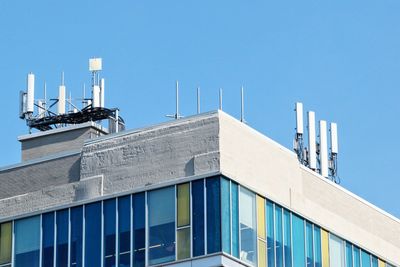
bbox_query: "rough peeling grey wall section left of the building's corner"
[81,113,219,194]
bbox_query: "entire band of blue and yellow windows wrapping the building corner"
[0,176,394,267]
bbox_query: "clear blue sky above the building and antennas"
[0,0,400,217]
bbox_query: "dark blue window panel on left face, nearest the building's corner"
[206,177,221,254]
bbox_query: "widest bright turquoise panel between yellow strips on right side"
[292,214,306,267]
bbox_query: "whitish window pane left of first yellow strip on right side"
[239,187,257,265]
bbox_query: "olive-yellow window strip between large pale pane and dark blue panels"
[177,183,191,260]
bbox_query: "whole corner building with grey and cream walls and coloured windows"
[0,111,400,267]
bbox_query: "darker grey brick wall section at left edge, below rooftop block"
[0,153,80,199]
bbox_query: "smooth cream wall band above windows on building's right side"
[220,113,400,264]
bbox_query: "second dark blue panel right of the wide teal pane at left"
[56,209,68,267]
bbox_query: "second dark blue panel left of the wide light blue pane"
[118,196,131,267]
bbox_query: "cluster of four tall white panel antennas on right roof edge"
[293,102,340,183]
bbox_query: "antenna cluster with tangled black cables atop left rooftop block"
[19,58,125,132]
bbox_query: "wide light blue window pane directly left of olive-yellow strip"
[148,187,175,265]
